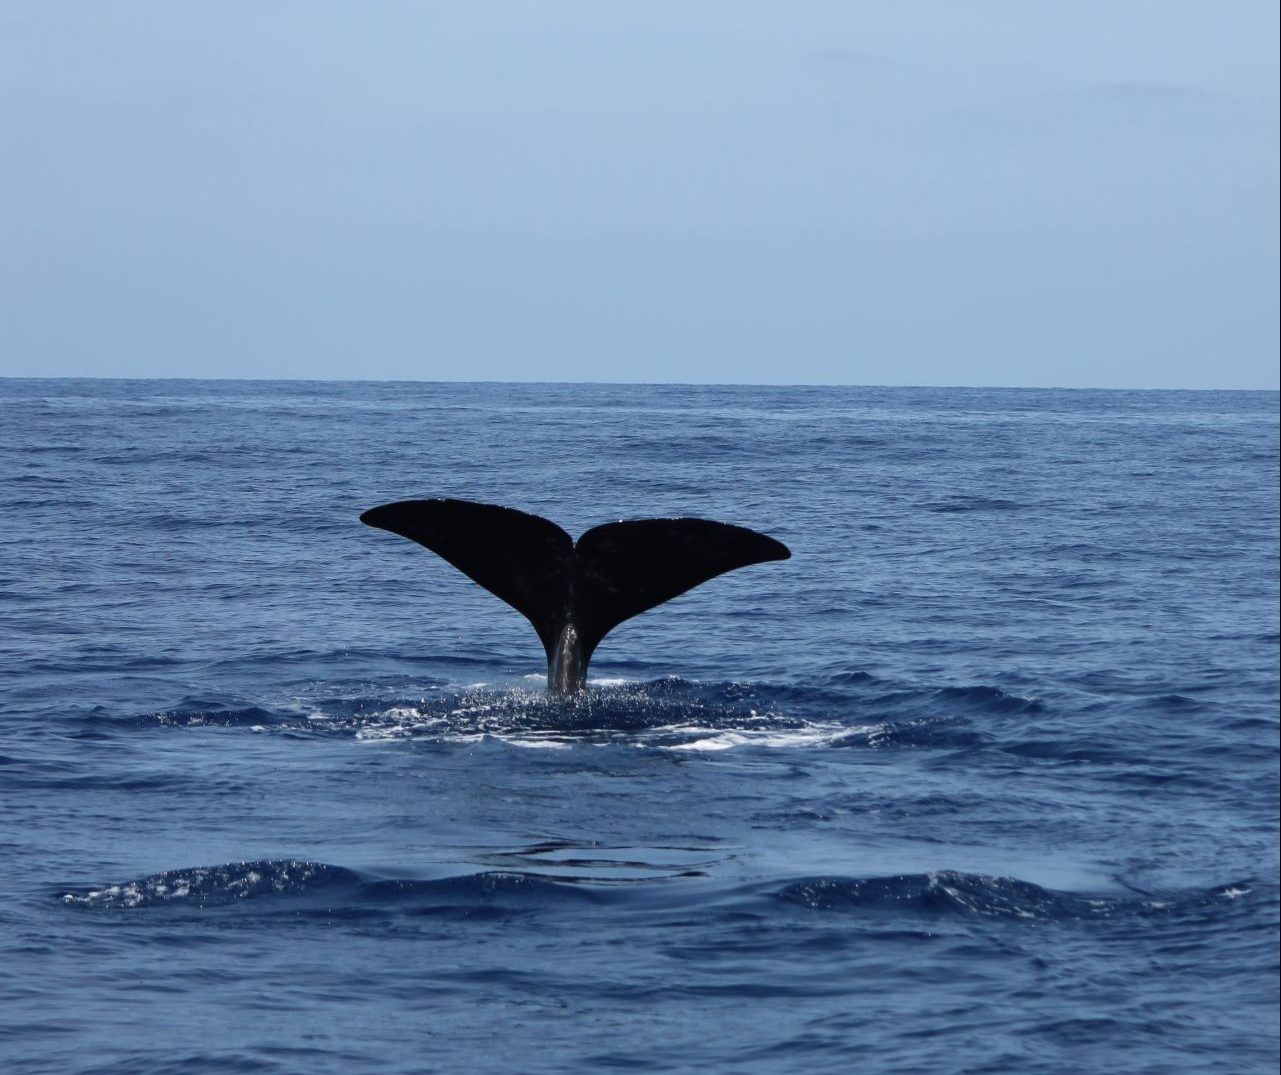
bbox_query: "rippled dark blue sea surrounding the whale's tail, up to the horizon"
[0,381,1278,1074]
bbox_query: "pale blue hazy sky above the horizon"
[0,0,1278,388]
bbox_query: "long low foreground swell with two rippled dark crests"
[56,846,1275,923]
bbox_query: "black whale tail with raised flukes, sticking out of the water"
[360,500,792,694]
